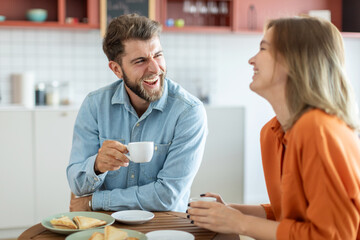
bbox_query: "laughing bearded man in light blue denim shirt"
[67,14,207,211]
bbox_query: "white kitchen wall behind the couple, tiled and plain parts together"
[0,28,360,203]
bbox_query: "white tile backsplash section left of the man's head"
[0,28,114,104]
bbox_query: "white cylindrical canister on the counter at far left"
[11,72,35,107]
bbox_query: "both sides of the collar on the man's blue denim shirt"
[111,78,169,111]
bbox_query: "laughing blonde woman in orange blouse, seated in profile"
[188,15,360,240]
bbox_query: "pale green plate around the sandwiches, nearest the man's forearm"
[41,212,115,235]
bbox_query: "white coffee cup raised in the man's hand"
[126,142,154,163]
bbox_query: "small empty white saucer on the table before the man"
[111,210,154,224]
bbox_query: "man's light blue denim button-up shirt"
[67,79,208,211]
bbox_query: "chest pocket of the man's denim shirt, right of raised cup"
[140,143,171,184]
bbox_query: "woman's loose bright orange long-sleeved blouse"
[260,110,360,240]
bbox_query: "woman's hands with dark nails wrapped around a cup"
[187,201,244,234]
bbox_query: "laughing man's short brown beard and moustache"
[122,69,166,102]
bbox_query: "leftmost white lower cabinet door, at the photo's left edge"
[0,111,35,229]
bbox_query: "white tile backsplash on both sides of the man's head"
[0,28,226,104]
